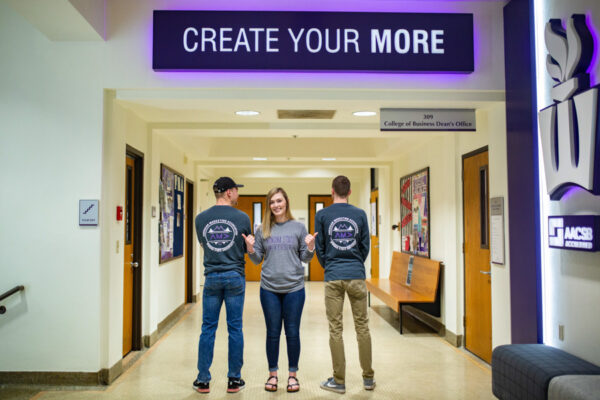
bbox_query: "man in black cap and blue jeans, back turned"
[193,177,252,393]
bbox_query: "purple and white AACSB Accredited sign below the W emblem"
[548,215,600,251]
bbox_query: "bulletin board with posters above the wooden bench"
[400,167,431,258]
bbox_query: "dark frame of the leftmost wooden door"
[125,145,144,351]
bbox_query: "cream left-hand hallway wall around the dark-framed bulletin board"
[101,101,199,366]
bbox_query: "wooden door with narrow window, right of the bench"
[463,149,492,363]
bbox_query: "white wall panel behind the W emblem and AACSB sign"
[534,0,600,364]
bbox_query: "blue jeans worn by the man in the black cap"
[198,271,246,382]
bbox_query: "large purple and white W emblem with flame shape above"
[539,14,600,200]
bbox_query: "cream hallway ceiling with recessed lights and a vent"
[117,89,504,166]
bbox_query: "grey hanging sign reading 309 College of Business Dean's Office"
[379,108,476,131]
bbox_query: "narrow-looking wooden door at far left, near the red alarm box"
[123,156,136,356]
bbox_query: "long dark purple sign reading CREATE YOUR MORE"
[152,10,473,73]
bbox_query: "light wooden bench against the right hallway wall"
[366,251,442,334]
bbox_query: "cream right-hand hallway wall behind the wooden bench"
[386,104,510,347]
